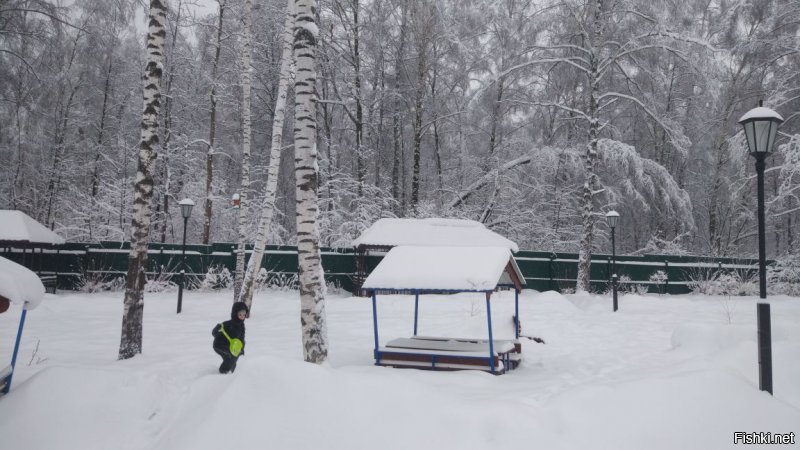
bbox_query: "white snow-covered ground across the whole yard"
[0,291,800,450]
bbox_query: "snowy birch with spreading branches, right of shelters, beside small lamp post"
[501,0,704,291]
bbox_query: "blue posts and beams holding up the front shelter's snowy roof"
[369,286,522,374]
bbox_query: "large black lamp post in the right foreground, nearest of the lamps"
[739,102,783,394]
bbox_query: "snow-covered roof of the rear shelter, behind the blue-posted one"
[353,218,519,252]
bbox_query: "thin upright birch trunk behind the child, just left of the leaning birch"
[233,0,253,307]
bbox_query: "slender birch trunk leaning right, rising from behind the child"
[238,0,295,311]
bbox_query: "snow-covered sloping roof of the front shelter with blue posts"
[362,246,524,291]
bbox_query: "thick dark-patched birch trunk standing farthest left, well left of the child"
[119,0,167,359]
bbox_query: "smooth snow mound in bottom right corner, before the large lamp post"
[550,370,800,450]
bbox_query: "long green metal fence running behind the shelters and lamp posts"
[0,242,757,294]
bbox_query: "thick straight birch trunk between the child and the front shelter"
[294,0,328,364]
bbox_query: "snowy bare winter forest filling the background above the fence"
[0,0,800,258]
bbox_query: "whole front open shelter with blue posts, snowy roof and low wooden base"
[363,246,525,374]
